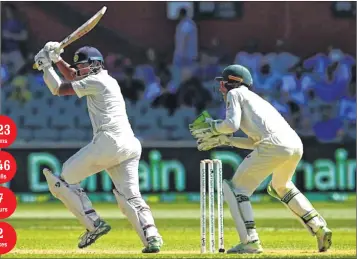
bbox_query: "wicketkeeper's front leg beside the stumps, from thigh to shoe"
[223,146,292,253]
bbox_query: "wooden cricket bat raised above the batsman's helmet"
[32,6,107,69]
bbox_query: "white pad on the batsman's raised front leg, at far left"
[43,169,99,231]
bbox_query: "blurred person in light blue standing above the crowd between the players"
[173,8,198,66]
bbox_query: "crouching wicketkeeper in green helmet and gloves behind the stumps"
[190,65,332,254]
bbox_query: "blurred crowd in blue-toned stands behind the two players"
[1,5,356,143]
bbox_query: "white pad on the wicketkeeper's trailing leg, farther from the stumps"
[267,183,327,236]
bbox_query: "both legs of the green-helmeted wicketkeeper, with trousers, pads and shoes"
[223,145,332,253]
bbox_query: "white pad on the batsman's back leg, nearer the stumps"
[113,189,159,247]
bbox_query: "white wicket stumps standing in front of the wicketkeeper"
[200,159,225,253]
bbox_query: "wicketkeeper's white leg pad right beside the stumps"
[223,180,259,244]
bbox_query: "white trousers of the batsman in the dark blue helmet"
[61,132,141,197]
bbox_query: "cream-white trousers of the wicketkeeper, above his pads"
[232,143,303,197]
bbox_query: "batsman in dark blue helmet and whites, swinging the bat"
[35,42,163,253]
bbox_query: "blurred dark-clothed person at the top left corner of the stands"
[1,3,28,75]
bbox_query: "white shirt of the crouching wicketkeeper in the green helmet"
[216,86,301,147]
